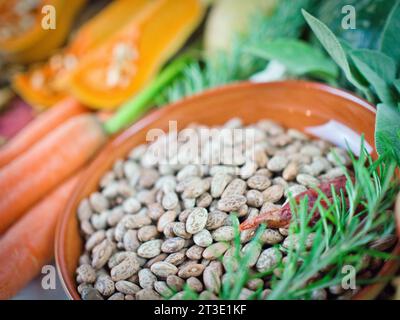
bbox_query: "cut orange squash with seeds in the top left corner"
[0,0,86,63]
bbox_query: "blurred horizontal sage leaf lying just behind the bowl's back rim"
[246,38,338,79]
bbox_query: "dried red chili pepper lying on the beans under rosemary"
[240,176,347,231]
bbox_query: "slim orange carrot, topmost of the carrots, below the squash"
[0,98,87,168]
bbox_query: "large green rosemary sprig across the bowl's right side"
[268,152,399,299]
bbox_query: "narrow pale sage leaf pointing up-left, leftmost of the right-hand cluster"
[302,10,368,93]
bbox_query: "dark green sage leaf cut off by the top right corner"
[379,0,400,61]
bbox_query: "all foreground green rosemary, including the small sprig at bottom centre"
[180,144,400,300]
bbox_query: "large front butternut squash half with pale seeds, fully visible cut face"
[68,0,205,109]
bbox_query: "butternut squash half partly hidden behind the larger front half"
[13,0,151,107]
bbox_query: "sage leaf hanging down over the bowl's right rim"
[375,103,400,161]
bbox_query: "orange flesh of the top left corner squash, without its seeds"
[0,0,86,63]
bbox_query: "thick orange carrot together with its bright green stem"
[0,59,187,234]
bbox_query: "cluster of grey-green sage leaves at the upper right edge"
[303,0,400,163]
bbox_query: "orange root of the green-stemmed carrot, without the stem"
[0,114,107,234]
